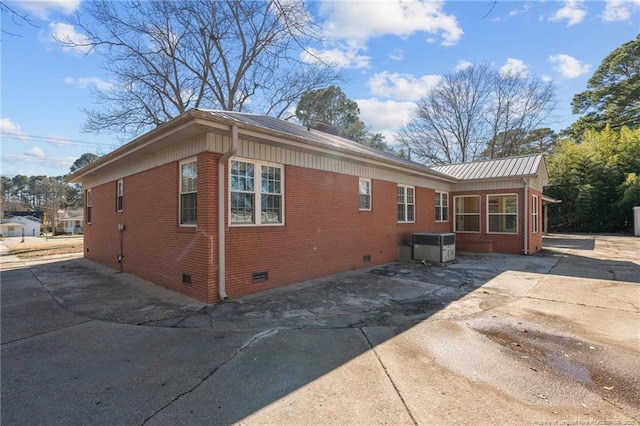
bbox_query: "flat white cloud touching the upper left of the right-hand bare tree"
[368,71,442,101]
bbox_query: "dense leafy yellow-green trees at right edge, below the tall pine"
[546,126,640,232]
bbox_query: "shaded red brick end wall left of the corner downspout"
[85,153,217,301]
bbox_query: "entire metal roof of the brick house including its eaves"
[66,109,548,185]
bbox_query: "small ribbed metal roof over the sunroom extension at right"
[432,154,546,180]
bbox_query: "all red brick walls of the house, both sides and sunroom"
[85,153,542,302]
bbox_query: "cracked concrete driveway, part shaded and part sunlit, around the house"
[0,236,640,425]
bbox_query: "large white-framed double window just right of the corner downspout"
[229,159,284,225]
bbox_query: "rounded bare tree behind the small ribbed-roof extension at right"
[397,64,556,164]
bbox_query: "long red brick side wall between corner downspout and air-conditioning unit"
[226,166,435,297]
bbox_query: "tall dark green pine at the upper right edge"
[571,35,640,136]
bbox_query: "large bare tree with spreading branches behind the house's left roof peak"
[59,0,342,135]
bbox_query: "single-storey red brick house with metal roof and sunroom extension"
[68,110,547,302]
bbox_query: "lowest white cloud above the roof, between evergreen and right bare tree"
[356,98,415,145]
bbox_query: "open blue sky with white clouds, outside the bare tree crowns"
[0,0,640,176]
